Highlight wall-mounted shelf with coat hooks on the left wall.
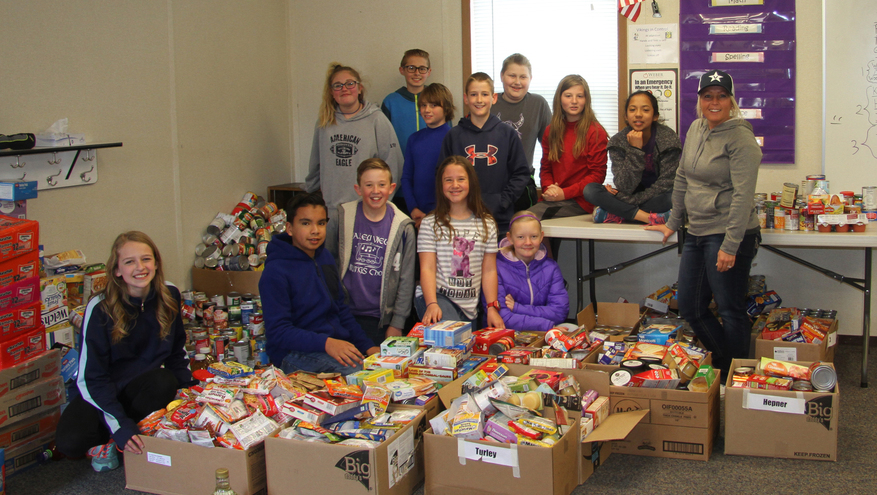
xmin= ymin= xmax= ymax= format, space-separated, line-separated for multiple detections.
xmin=0 ymin=143 xmax=122 ymax=191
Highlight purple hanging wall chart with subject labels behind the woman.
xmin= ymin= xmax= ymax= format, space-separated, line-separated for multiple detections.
xmin=679 ymin=0 xmax=796 ymax=163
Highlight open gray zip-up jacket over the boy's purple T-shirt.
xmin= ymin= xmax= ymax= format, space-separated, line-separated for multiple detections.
xmin=338 ymin=201 xmax=417 ymax=329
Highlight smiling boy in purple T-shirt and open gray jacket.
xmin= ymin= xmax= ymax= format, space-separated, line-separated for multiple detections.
xmin=338 ymin=158 xmax=417 ymax=345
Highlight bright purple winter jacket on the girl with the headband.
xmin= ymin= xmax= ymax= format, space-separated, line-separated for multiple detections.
xmin=485 ymin=239 xmax=569 ymax=332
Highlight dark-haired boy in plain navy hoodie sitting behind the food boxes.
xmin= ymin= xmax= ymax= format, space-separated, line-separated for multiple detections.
xmin=259 ymin=193 xmax=381 ymax=374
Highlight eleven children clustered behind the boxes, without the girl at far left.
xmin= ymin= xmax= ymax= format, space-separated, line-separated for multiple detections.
xmin=270 ymin=50 xmax=681 ymax=372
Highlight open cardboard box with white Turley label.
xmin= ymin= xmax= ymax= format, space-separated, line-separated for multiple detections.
xmin=424 ymin=365 xmax=642 ymax=495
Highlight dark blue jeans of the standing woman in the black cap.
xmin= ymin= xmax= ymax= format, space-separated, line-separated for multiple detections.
xmin=677 ymin=233 xmax=761 ymax=376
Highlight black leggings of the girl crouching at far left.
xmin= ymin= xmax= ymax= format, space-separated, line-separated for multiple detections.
xmin=55 ymin=368 xmax=179 ymax=458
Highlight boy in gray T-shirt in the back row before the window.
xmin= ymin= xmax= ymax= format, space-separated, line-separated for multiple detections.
xmin=492 ymin=53 xmax=551 ymax=210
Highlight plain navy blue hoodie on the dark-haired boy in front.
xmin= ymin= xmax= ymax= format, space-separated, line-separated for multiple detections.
xmin=259 ymin=234 xmax=374 ymax=366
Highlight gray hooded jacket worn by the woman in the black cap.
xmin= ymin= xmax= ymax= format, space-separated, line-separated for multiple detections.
xmin=667 ymin=118 xmax=762 ymax=256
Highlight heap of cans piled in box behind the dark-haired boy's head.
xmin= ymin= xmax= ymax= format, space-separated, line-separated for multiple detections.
xmin=195 ymin=192 xmax=286 ymax=271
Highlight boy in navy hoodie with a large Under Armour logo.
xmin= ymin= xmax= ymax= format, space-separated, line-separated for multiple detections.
xmin=439 ymin=72 xmax=530 ymax=236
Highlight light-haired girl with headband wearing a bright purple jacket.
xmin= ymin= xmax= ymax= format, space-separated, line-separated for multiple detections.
xmin=496 ymin=211 xmax=569 ymax=332
